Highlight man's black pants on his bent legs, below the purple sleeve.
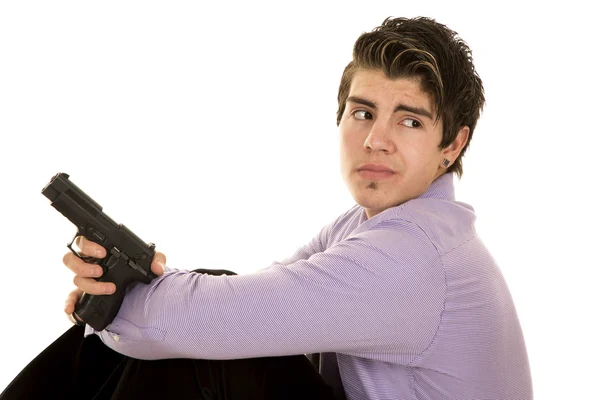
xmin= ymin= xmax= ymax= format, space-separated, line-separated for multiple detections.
xmin=0 ymin=270 xmax=334 ymax=400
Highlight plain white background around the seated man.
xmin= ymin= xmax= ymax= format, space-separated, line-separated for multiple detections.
xmin=0 ymin=1 xmax=600 ymax=400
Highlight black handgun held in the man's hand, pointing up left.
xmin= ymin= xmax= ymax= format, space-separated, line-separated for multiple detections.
xmin=42 ymin=173 xmax=157 ymax=331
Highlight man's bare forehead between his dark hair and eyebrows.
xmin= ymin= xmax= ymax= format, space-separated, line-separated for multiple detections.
xmin=348 ymin=69 xmax=433 ymax=111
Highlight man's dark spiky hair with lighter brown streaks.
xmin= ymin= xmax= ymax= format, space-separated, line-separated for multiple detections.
xmin=337 ymin=17 xmax=485 ymax=177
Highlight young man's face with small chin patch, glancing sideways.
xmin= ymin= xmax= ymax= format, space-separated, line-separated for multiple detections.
xmin=340 ymin=70 xmax=462 ymax=218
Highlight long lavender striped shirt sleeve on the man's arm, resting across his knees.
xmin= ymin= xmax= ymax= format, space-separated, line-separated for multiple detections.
xmin=97 ymin=221 xmax=445 ymax=362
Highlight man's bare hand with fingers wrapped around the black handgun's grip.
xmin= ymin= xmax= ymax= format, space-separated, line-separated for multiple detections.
xmin=63 ymin=236 xmax=167 ymax=317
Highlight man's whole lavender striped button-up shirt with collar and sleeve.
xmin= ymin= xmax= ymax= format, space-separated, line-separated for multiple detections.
xmin=86 ymin=174 xmax=533 ymax=400
